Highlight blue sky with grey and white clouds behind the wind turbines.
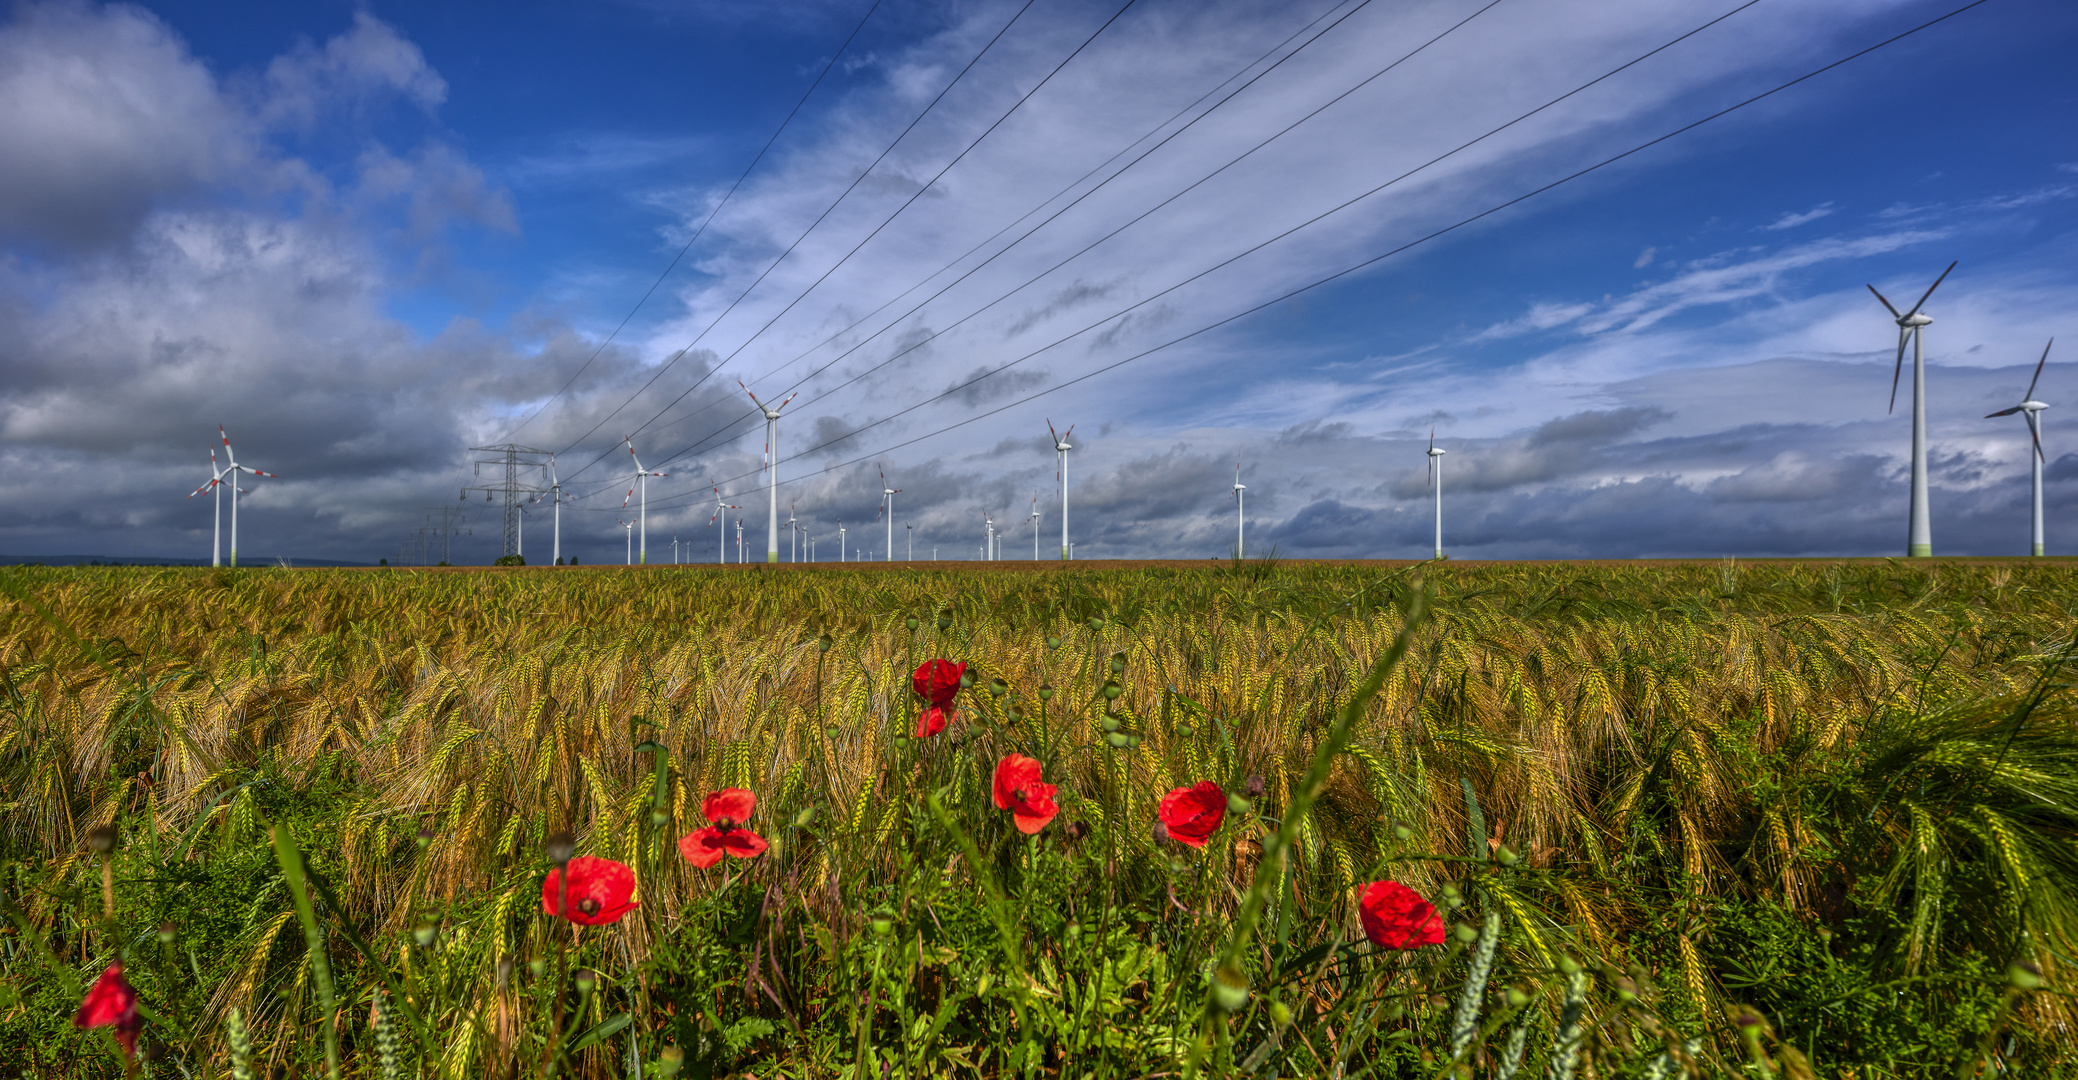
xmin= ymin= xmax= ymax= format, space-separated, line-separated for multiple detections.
xmin=0 ymin=0 xmax=2078 ymax=565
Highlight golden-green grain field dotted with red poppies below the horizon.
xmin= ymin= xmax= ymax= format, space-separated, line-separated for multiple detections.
xmin=0 ymin=561 xmax=2078 ymax=1080
